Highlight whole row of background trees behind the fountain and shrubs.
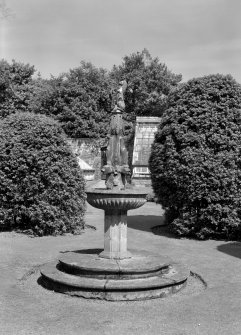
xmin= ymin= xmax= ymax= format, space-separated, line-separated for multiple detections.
xmin=0 ymin=49 xmax=181 ymax=139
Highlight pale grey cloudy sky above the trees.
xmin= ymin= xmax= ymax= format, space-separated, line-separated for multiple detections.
xmin=0 ymin=0 xmax=241 ymax=83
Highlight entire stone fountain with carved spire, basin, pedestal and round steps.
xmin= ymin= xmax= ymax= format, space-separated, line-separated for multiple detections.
xmin=41 ymin=80 xmax=190 ymax=301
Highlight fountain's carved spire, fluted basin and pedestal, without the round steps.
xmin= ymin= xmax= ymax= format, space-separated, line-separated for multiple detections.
xmin=87 ymin=80 xmax=148 ymax=259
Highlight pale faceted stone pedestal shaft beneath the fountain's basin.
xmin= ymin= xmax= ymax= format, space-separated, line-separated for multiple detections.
xmin=99 ymin=209 xmax=131 ymax=259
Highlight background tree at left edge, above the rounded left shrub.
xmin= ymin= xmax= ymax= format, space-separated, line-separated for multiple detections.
xmin=0 ymin=60 xmax=35 ymax=118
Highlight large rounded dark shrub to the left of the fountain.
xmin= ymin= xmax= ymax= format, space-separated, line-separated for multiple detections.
xmin=0 ymin=112 xmax=85 ymax=236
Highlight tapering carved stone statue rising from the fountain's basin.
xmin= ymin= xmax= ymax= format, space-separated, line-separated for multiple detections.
xmin=102 ymin=80 xmax=130 ymax=189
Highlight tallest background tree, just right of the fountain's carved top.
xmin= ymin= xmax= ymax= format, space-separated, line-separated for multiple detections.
xmin=110 ymin=49 xmax=181 ymax=135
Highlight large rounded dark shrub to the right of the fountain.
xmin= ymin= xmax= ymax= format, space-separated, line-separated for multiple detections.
xmin=150 ymin=75 xmax=241 ymax=239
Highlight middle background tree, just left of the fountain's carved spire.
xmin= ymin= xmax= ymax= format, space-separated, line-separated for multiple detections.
xmin=34 ymin=62 xmax=114 ymax=138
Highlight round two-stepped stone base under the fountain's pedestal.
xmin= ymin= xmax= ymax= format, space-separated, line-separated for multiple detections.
xmin=41 ymin=250 xmax=190 ymax=301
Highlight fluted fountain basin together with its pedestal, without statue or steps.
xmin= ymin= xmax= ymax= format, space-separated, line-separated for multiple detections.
xmin=86 ymin=189 xmax=147 ymax=259
